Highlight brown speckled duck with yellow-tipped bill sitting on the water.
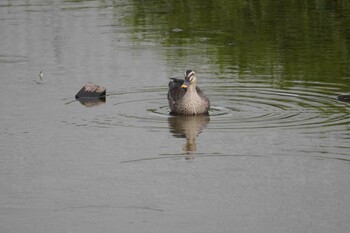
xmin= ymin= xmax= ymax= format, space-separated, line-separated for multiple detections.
xmin=167 ymin=70 xmax=210 ymax=115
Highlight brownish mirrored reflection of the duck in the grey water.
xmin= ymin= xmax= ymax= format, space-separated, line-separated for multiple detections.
xmin=168 ymin=115 xmax=210 ymax=159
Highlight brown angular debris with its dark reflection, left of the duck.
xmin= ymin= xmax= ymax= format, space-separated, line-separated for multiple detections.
xmin=75 ymin=82 xmax=107 ymax=107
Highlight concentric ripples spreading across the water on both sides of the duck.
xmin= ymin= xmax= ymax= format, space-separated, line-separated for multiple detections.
xmin=69 ymin=81 xmax=350 ymax=133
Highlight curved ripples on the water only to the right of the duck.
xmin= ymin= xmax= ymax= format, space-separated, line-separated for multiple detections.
xmin=208 ymin=80 xmax=350 ymax=129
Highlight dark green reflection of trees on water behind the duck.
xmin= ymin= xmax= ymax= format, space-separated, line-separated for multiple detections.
xmin=127 ymin=0 xmax=350 ymax=82
